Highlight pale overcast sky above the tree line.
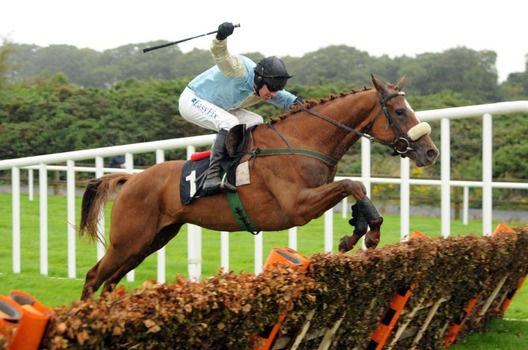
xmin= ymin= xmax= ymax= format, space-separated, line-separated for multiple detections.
xmin=0 ymin=0 xmax=528 ymax=81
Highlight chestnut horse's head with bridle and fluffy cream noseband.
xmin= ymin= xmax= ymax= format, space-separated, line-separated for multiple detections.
xmin=370 ymin=76 xmax=439 ymax=167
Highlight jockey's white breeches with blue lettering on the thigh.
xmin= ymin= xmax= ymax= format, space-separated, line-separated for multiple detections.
xmin=179 ymin=87 xmax=264 ymax=131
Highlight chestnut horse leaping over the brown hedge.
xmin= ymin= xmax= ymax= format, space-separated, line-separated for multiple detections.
xmin=79 ymin=75 xmax=439 ymax=299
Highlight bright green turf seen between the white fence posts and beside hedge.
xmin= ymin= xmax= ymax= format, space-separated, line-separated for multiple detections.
xmin=0 ymin=194 xmax=528 ymax=350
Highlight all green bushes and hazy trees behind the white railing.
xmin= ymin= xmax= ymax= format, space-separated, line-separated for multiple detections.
xmin=0 ymin=42 xmax=528 ymax=208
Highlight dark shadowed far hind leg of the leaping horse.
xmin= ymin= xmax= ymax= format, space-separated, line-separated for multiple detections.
xmin=104 ymin=224 xmax=183 ymax=292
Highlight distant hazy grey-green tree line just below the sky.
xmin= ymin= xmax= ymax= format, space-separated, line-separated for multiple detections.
xmin=8 ymin=41 xmax=528 ymax=102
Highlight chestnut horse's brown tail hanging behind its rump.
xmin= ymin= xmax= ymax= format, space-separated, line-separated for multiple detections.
xmin=79 ymin=173 xmax=132 ymax=240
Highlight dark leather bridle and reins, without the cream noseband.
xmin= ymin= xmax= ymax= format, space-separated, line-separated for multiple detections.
xmin=300 ymin=91 xmax=424 ymax=157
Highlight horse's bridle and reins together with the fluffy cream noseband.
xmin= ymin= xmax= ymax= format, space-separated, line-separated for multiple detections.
xmin=301 ymin=91 xmax=431 ymax=157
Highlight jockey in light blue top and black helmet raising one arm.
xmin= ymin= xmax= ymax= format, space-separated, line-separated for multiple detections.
xmin=179 ymin=22 xmax=303 ymax=194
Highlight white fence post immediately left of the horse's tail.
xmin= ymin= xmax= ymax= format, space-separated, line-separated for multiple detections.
xmin=66 ymin=160 xmax=76 ymax=278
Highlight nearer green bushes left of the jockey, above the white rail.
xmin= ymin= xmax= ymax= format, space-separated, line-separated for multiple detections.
xmin=0 ymin=74 xmax=204 ymax=163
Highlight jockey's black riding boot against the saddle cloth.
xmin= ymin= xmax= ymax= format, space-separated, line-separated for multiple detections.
xmin=203 ymin=130 xmax=236 ymax=194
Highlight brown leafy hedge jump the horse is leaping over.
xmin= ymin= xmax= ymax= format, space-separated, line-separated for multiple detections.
xmin=24 ymin=226 xmax=528 ymax=349
